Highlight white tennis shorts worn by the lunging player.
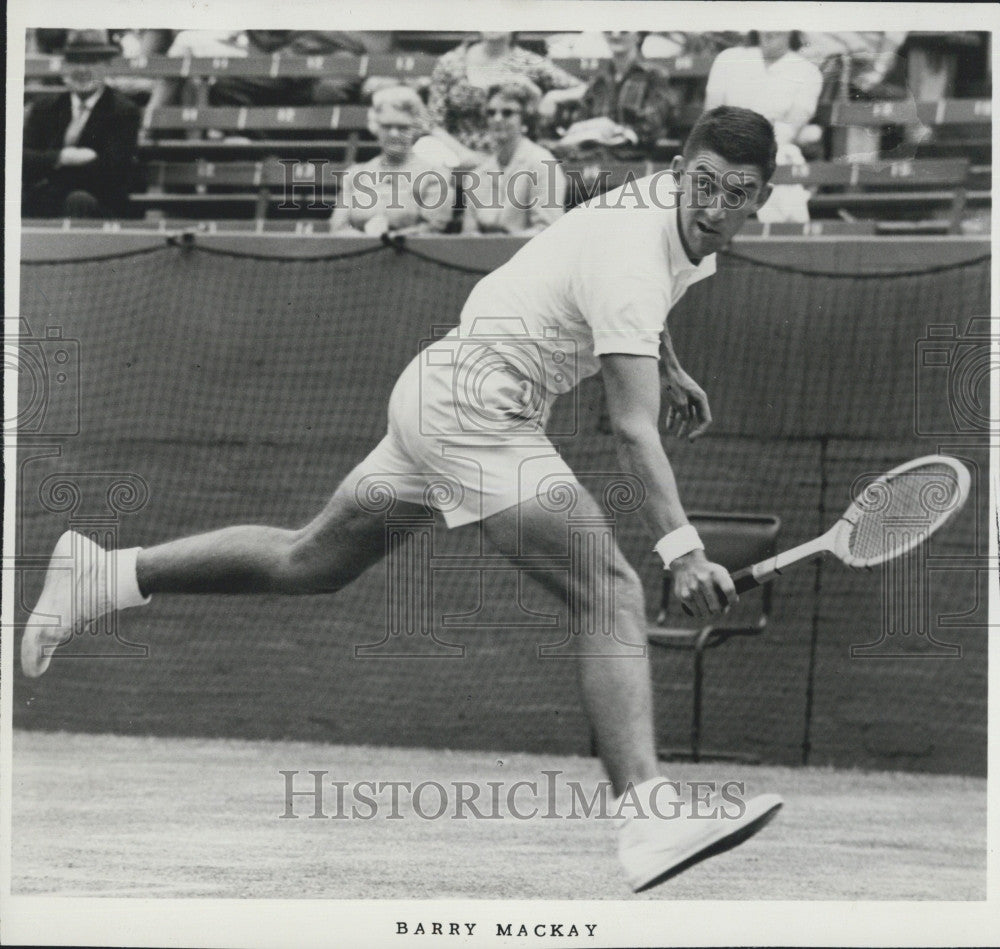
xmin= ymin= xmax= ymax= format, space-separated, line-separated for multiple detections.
xmin=347 ymin=335 xmax=582 ymax=528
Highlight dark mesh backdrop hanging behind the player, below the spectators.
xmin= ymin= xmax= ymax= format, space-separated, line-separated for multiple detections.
xmin=15 ymin=235 xmax=989 ymax=773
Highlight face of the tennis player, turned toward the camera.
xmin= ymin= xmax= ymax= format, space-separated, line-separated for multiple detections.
xmin=671 ymin=149 xmax=771 ymax=257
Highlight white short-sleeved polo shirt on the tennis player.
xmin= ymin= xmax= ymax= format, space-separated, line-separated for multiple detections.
xmin=458 ymin=172 xmax=715 ymax=395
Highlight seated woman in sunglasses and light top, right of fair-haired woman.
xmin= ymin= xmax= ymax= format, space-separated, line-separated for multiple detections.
xmin=462 ymin=83 xmax=566 ymax=236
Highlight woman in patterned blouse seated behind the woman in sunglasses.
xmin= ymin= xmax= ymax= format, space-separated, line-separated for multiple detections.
xmin=427 ymin=33 xmax=586 ymax=168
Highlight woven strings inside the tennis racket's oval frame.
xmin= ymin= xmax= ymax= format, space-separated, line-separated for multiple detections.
xmin=848 ymin=462 xmax=962 ymax=560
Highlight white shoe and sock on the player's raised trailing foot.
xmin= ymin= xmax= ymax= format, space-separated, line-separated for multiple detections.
xmin=21 ymin=531 xmax=149 ymax=678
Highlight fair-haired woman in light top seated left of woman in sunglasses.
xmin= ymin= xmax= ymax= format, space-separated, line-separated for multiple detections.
xmin=330 ymin=86 xmax=453 ymax=234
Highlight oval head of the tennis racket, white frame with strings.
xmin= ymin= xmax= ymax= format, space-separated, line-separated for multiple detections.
xmin=829 ymin=455 xmax=972 ymax=568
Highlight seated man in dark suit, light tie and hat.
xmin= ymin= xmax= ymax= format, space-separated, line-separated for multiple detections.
xmin=21 ymin=30 xmax=142 ymax=217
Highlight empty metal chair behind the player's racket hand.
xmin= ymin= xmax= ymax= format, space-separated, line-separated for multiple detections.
xmin=649 ymin=513 xmax=781 ymax=762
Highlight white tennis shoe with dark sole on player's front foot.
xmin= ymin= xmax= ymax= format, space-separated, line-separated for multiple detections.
xmin=618 ymin=794 xmax=784 ymax=893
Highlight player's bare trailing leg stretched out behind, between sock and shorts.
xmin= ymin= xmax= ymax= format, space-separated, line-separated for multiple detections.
xmin=136 ymin=477 xmax=423 ymax=595
